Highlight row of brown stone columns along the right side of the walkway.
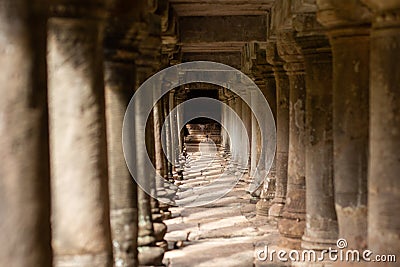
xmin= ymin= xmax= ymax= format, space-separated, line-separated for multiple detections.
xmin=220 ymin=0 xmax=400 ymax=262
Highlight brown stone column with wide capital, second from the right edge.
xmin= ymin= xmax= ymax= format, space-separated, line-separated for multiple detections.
xmin=318 ymin=0 xmax=370 ymax=249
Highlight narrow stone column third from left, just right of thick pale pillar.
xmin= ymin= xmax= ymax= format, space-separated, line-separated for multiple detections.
xmin=104 ymin=15 xmax=138 ymax=267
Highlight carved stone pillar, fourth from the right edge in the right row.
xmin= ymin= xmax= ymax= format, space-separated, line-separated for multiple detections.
xmin=278 ymin=30 xmax=306 ymax=249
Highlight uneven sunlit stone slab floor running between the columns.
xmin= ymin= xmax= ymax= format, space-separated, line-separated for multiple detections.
xmin=164 ymin=143 xmax=285 ymax=267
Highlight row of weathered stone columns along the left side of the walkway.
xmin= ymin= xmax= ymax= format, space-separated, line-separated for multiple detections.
xmin=0 ymin=0 xmax=179 ymax=266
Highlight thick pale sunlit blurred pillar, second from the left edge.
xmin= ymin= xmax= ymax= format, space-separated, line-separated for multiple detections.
xmin=48 ymin=0 xmax=112 ymax=266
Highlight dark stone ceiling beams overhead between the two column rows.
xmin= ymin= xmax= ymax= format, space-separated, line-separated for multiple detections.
xmin=169 ymin=0 xmax=274 ymax=68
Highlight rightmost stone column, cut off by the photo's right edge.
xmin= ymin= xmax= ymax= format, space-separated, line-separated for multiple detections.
xmin=364 ymin=0 xmax=400 ymax=260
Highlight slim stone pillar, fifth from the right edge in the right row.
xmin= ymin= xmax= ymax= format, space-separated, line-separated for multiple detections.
xmin=267 ymin=42 xmax=289 ymax=218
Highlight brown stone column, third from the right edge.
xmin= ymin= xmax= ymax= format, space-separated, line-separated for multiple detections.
xmin=294 ymin=13 xmax=338 ymax=249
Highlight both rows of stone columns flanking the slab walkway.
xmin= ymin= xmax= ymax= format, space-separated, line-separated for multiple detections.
xmin=0 ymin=0 xmax=400 ymax=266
